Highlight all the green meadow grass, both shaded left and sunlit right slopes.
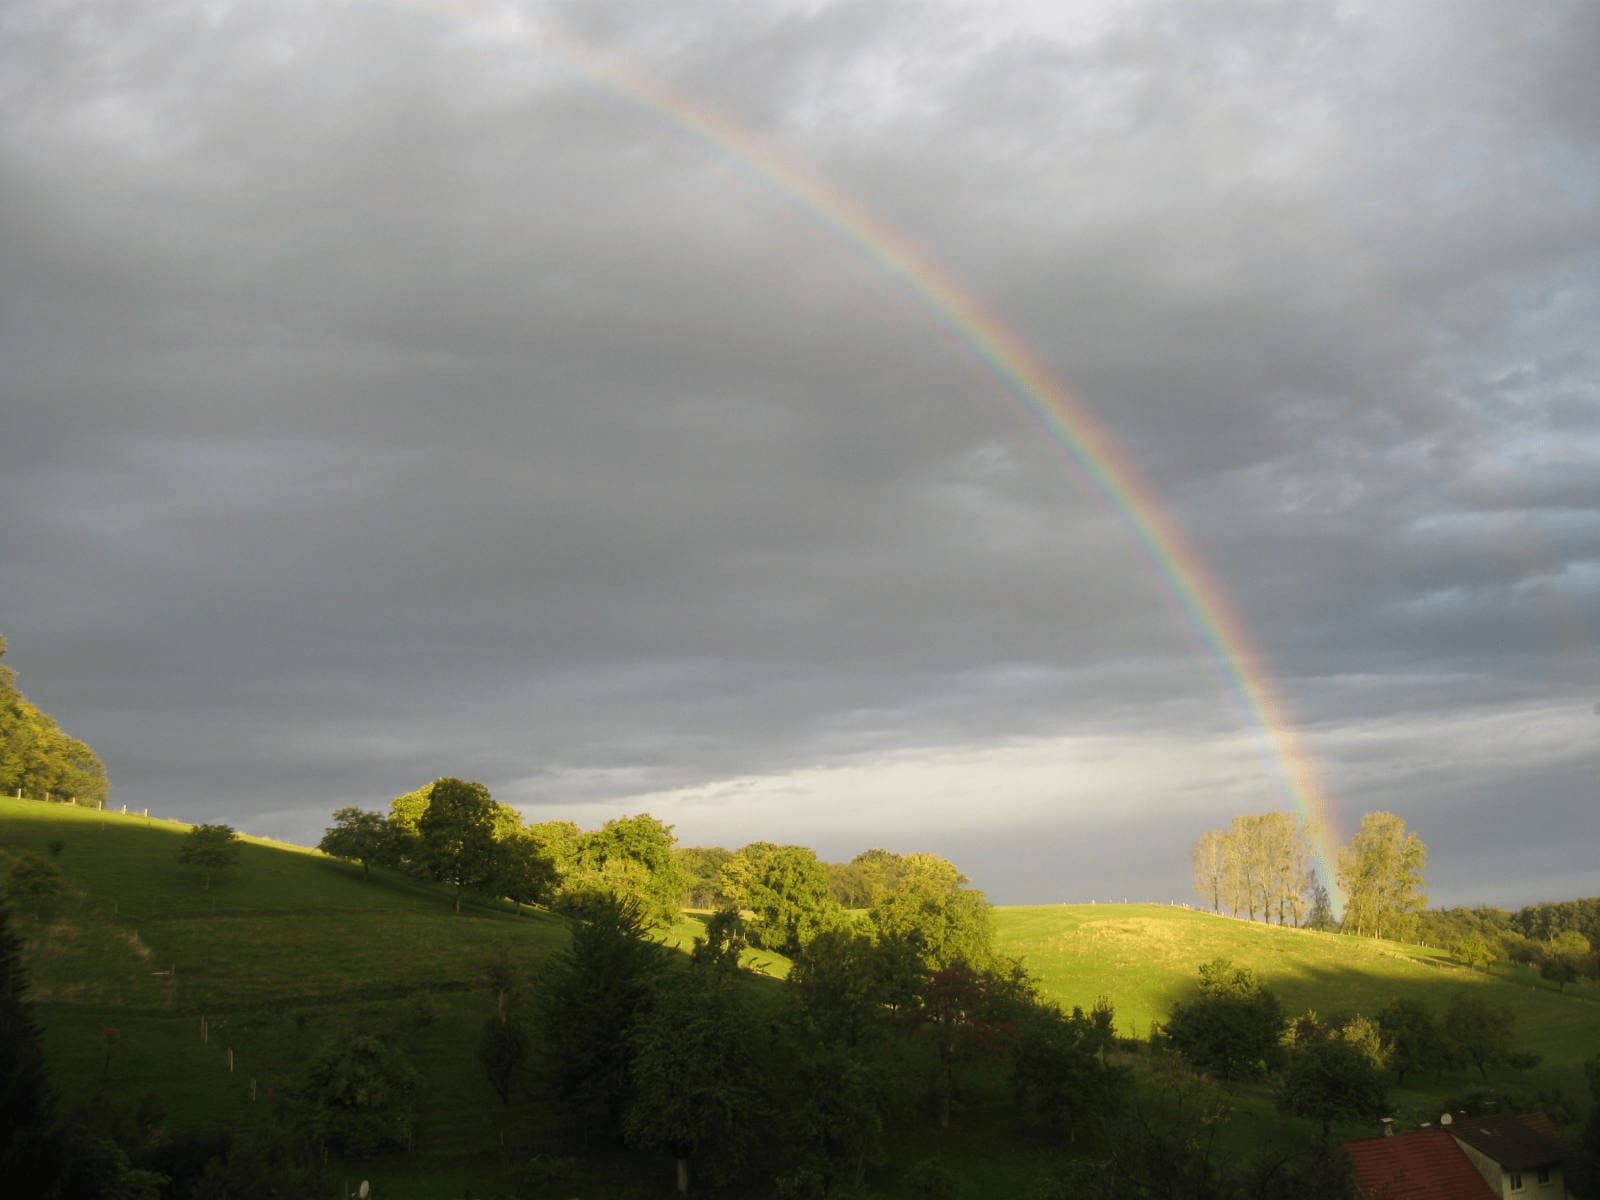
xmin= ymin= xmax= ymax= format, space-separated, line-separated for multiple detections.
xmin=0 ymin=798 xmax=1600 ymax=1200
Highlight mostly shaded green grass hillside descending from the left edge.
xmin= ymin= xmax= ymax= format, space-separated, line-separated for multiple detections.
xmin=0 ymin=798 xmax=789 ymax=1200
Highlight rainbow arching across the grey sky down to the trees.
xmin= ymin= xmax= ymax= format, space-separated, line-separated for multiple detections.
xmin=377 ymin=0 xmax=1344 ymax=915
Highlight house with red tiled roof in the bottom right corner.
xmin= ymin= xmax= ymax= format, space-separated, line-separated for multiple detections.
xmin=1344 ymin=1114 xmax=1570 ymax=1200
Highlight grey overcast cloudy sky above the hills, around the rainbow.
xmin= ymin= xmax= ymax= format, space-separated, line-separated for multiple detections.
xmin=0 ymin=0 xmax=1600 ymax=906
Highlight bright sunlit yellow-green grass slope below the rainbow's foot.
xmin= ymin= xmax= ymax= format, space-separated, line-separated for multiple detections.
xmin=995 ymin=904 xmax=1600 ymax=1096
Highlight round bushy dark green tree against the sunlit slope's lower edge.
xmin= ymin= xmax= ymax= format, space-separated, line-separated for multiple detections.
xmin=1166 ymin=958 xmax=1283 ymax=1082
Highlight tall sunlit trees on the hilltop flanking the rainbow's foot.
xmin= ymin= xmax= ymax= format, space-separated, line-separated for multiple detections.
xmin=1194 ymin=813 xmax=1427 ymax=938
